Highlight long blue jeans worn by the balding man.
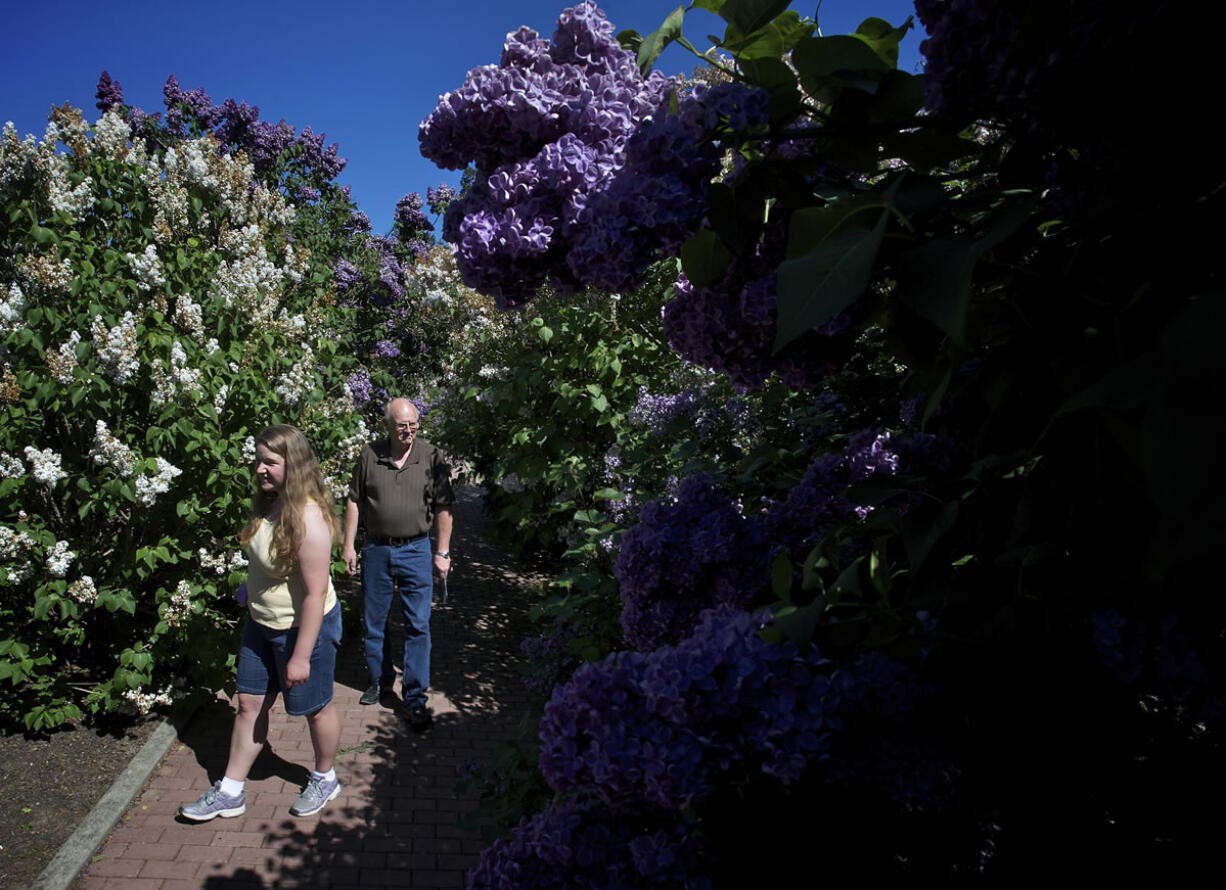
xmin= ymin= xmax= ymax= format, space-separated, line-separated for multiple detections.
xmin=362 ymin=537 xmax=434 ymax=707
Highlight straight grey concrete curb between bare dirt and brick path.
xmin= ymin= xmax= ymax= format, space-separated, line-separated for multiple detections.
xmin=31 ymin=720 xmax=179 ymax=890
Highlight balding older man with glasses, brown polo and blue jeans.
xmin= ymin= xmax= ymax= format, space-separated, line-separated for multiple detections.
xmin=341 ymin=398 xmax=455 ymax=731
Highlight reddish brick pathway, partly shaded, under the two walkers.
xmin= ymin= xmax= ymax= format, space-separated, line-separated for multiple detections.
xmin=75 ymin=489 xmax=541 ymax=890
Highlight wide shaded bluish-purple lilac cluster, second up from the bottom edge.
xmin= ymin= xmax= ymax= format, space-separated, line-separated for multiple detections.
xmin=541 ymin=606 xmax=917 ymax=810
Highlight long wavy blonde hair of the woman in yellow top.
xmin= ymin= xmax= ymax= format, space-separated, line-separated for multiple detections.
xmin=239 ymin=423 xmax=341 ymax=565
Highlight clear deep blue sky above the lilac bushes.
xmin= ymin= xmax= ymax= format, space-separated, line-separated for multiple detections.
xmin=0 ymin=0 xmax=922 ymax=230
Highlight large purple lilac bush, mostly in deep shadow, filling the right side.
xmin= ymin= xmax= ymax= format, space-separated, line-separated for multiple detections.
xmin=421 ymin=0 xmax=1224 ymax=888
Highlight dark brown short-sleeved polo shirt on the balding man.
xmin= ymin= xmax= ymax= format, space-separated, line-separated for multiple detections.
xmin=349 ymin=439 xmax=455 ymax=538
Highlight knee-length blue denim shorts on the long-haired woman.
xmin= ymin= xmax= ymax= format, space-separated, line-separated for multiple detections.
xmin=238 ymin=602 xmax=341 ymax=717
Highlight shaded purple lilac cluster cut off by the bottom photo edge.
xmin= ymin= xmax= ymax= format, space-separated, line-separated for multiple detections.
xmin=468 ymin=801 xmax=711 ymax=890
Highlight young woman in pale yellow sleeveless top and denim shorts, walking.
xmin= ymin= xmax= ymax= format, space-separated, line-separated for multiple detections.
xmin=179 ymin=425 xmax=341 ymax=821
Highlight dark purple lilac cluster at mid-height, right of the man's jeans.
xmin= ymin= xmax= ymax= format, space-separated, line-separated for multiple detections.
xmin=613 ymin=473 xmax=766 ymax=650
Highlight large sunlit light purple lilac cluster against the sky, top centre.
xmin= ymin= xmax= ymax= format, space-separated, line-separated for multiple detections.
xmin=419 ymin=1 xmax=765 ymax=306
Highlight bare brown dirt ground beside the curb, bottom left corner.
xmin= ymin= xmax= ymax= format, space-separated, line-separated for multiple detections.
xmin=0 ymin=717 xmax=159 ymax=890
